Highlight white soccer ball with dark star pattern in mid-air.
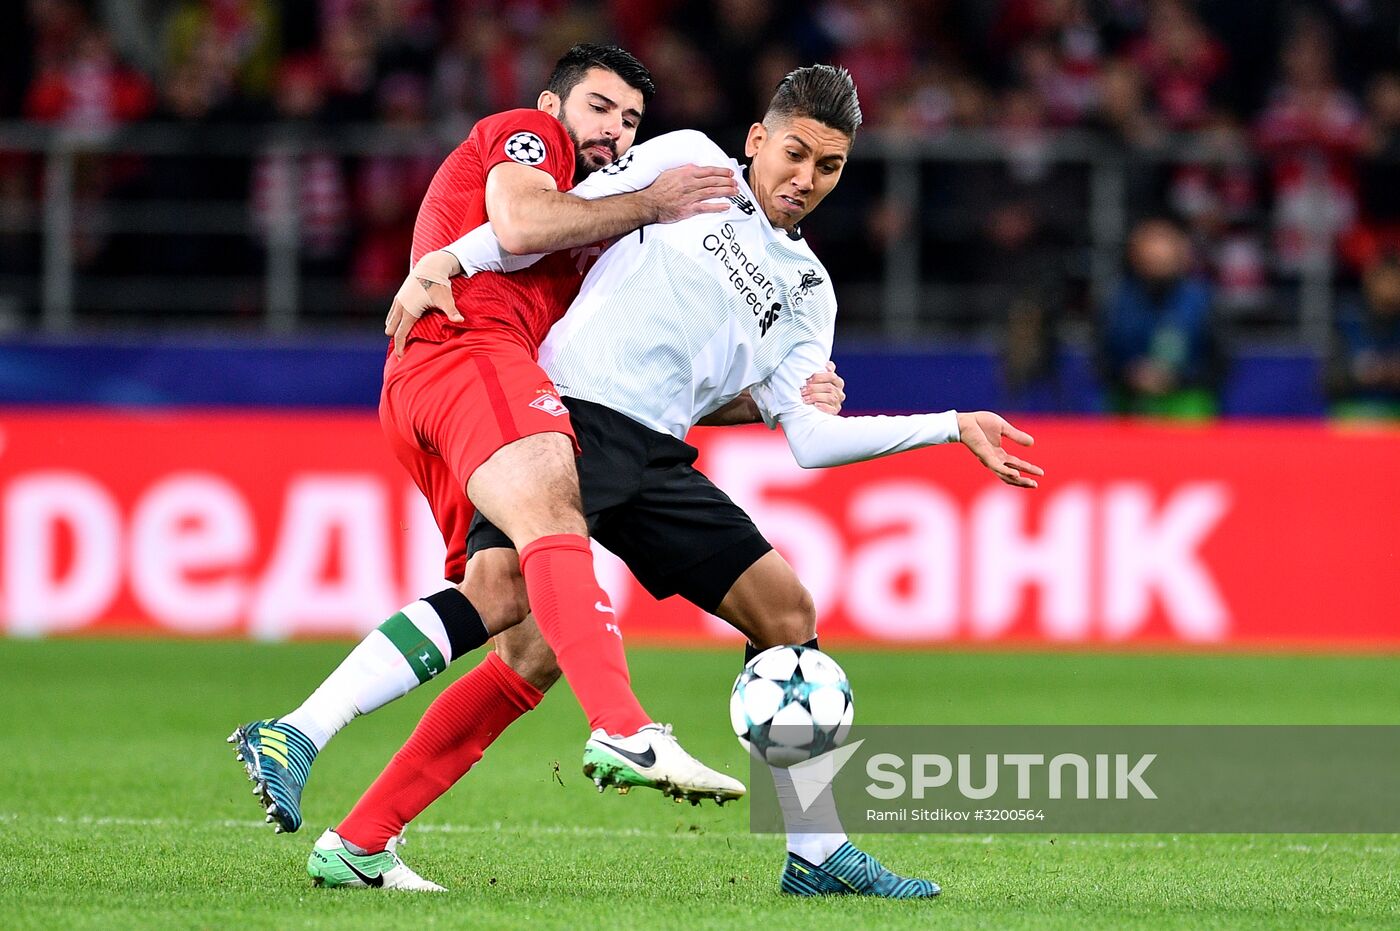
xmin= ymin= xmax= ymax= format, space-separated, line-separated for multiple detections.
xmin=729 ymin=647 xmax=855 ymax=767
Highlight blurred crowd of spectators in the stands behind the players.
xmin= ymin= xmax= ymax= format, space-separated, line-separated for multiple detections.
xmin=0 ymin=0 xmax=1400 ymax=416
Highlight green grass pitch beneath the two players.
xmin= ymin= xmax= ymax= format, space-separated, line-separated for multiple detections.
xmin=0 ymin=640 xmax=1400 ymax=931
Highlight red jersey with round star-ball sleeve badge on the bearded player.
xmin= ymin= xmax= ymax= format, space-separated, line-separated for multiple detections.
xmin=409 ymin=109 xmax=598 ymax=353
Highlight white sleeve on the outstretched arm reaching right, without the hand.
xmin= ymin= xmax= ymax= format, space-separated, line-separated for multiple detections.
xmin=750 ymin=322 xmax=958 ymax=469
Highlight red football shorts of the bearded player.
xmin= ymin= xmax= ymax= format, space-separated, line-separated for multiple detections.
xmin=379 ymin=330 xmax=578 ymax=581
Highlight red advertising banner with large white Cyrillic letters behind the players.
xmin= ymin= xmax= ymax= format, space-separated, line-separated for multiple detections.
xmin=0 ymin=410 xmax=1400 ymax=648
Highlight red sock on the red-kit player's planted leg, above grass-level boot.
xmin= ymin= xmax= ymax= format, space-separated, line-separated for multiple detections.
xmin=336 ymin=652 xmax=545 ymax=853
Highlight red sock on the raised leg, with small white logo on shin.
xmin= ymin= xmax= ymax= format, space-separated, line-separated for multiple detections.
xmin=521 ymin=533 xmax=651 ymax=735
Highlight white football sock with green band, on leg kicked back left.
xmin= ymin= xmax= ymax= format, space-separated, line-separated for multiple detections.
xmin=280 ymin=601 xmax=452 ymax=750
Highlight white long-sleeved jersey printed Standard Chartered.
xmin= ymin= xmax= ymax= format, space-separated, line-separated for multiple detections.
xmin=448 ymin=130 xmax=958 ymax=466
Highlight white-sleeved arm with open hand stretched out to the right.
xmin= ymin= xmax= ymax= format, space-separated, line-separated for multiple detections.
xmin=752 ymin=337 xmax=1044 ymax=489
